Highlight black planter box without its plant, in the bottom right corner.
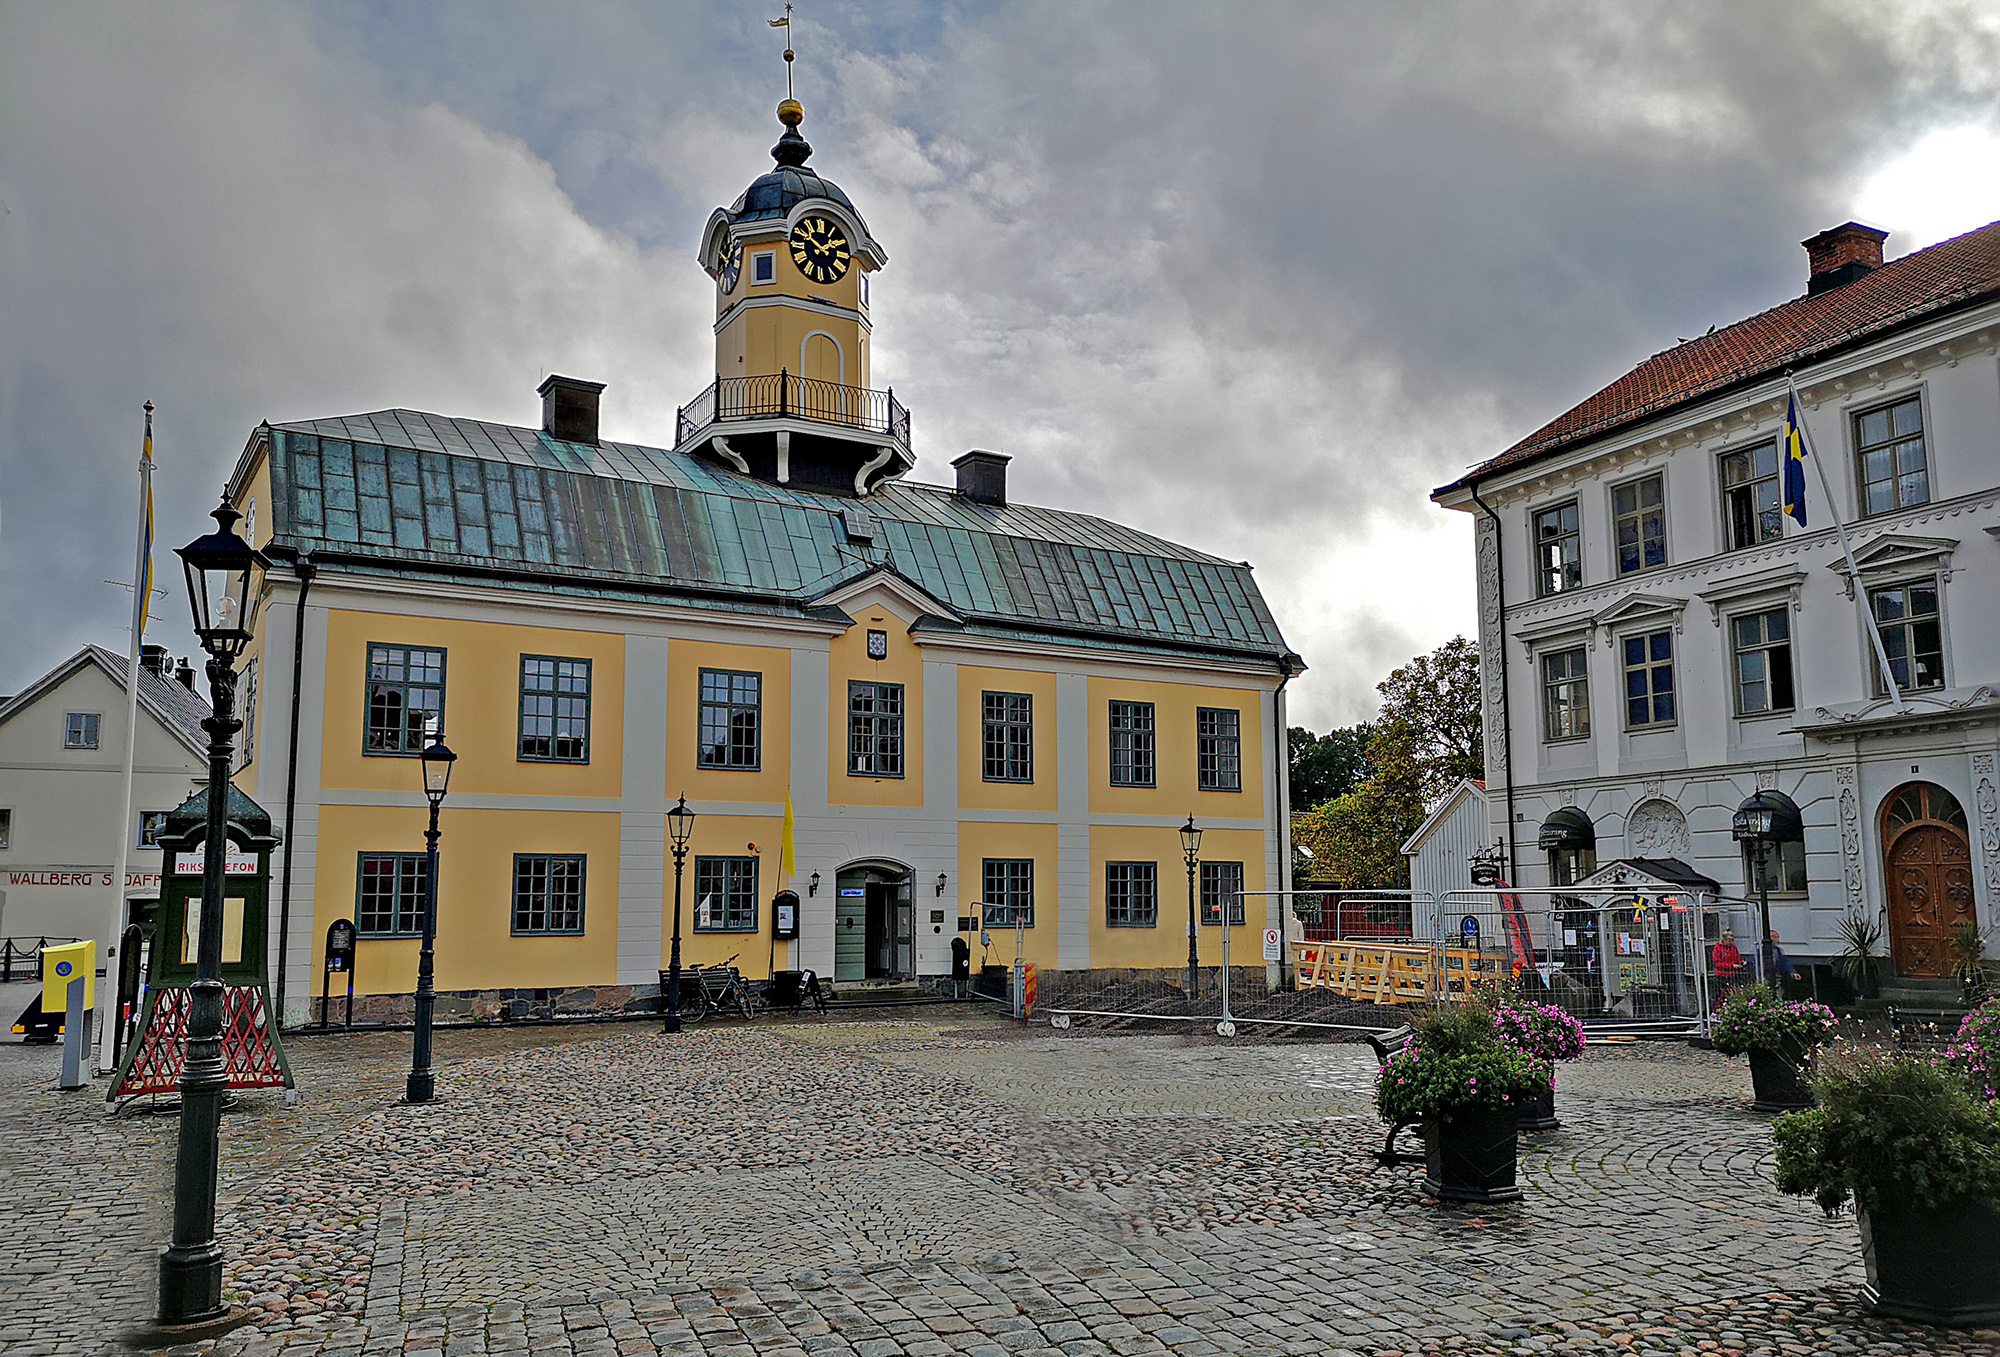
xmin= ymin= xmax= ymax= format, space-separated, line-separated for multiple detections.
xmin=1858 ymin=1201 xmax=2000 ymax=1325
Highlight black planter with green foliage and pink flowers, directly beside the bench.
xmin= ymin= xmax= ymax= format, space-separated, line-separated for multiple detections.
xmin=1376 ymin=1003 xmax=1556 ymax=1203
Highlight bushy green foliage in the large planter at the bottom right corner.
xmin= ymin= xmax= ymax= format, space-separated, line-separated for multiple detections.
xmin=1772 ymin=1043 xmax=2000 ymax=1215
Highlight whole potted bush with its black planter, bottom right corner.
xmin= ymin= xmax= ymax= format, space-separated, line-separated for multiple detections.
xmin=1772 ymin=1013 xmax=2000 ymax=1325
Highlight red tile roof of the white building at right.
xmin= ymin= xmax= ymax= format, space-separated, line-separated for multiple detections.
xmin=1438 ymin=222 xmax=2000 ymax=494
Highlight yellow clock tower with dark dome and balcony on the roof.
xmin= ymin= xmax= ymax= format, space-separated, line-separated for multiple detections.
xmin=676 ymin=98 xmax=914 ymax=494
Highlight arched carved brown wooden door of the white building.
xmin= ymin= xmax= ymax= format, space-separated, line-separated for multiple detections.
xmin=1882 ymin=783 xmax=1976 ymax=977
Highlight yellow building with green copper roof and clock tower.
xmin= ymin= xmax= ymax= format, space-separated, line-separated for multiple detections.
xmin=230 ymin=104 xmax=1302 ymax=1023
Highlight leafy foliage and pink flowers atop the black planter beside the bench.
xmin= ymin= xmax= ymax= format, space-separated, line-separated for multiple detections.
xmin=1376 ymin=1003 xmax=1556 ymax=1121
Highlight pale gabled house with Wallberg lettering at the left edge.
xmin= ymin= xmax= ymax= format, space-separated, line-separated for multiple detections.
xmin=0 ymin=646 xmax=208 ymax=965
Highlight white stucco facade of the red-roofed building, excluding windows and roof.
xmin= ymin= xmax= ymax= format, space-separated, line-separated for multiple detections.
xmin=1438 ymin=236 xmax=2000 ymax=975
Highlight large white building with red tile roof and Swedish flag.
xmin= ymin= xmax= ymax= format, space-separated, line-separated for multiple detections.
xmin=1434 ymin=222 xmax=2000 ymax=979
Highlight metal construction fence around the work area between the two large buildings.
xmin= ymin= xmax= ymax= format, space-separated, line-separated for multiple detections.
xmin=1032 ymin=885 xmax=1766 ymax=1039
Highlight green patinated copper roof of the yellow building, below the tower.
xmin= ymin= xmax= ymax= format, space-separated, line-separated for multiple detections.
xmin=272 ymin=410 xmax=1288 ymax=658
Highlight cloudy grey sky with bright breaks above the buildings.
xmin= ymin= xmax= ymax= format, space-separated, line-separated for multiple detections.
xmin=0 ymin=0 xmax=2000 ymax=731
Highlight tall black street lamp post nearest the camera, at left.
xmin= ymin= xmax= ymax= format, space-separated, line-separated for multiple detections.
xmin=160 ymin=500 xmax=270 ymax=1329
